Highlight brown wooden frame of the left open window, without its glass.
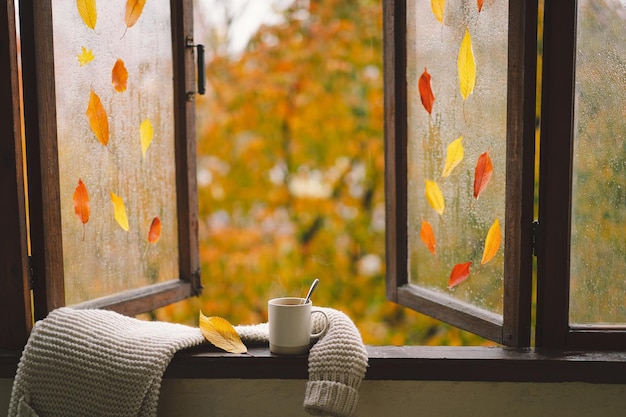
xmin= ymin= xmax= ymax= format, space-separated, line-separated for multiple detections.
xmin=15 ymin=0 xmax=201 ymax=320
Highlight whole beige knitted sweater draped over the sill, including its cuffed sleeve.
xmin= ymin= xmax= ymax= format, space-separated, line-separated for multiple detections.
xmin=8 ymin=308 xmax=367 ymax=417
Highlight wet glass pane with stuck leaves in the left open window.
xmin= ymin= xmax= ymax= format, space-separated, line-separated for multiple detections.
xmin=52 ymin=0 xmax=178 ymax=304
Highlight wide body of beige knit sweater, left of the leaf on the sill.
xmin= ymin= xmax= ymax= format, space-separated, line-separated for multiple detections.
xmin=8 ymin=308 xmax=204 ymax=417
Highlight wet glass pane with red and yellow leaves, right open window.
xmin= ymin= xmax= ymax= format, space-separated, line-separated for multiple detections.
xmin=407 ymin=0 xmax=508 ymax=314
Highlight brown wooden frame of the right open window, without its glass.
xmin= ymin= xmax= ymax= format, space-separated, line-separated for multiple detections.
xmin=383 ymin=0 xmax=537 ymax=346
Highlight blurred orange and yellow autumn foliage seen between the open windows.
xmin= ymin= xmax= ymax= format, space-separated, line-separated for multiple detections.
xmin=156 ymin=0 xmax=485 ymax=345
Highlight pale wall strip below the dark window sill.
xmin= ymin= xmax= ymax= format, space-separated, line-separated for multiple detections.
xmin=0 ymin=378 xmax=626 ymax=417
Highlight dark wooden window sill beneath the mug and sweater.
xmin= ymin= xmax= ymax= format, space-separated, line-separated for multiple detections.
xmin=0 ymin=346 xmax=626 ymax=384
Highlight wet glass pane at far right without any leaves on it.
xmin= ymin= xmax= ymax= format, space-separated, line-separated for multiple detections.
xmin=570 ymin=0 xmax=626 ymax=324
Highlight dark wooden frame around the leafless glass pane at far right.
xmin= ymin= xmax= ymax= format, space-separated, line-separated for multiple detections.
xmin=536 ymin=0 xmax=626 ymax=350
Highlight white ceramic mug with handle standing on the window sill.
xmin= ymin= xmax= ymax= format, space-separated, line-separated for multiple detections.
xmin=267 ymin=297 xmax=328 ymax=355
